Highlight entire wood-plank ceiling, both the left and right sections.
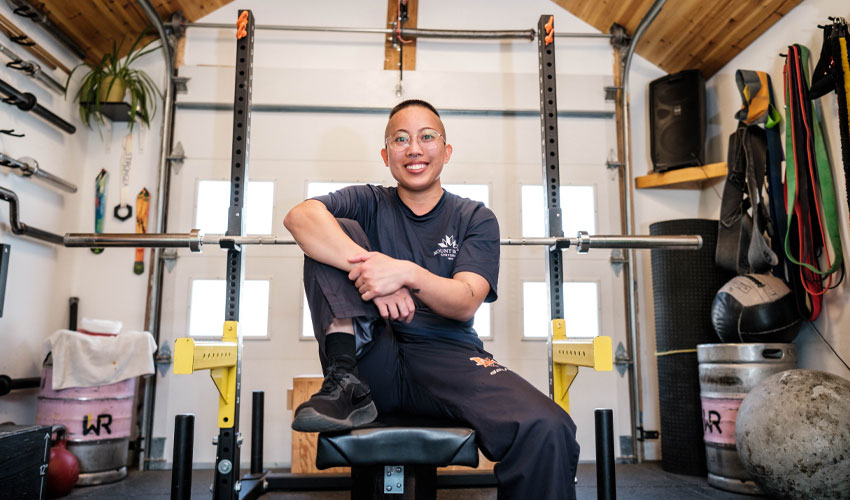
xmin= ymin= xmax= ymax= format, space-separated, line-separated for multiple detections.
xmin=15 ymin=0 xmax=801 ymax=78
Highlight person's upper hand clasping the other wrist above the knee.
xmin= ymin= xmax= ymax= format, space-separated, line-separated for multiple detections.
xmin=348 ymin=252 xmax=410 ymax=301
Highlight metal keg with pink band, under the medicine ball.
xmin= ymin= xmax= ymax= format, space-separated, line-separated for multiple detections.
xmin=697 ymin=343 xmax=797 ymax=495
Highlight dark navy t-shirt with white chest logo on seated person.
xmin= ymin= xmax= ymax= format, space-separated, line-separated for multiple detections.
xmin=315 ymin=184 xmax=499 ymax=347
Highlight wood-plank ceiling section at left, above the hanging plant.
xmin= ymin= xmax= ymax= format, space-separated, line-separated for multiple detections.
xmin=24 ymin=0 xmax=233 ymax=63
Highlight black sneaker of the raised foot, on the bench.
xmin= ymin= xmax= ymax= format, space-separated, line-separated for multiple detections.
xmin=292 ymin=366 xmax=378 ymax=432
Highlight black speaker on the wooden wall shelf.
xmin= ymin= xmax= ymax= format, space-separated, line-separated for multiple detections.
xmin=649 ymin=69 xmax=705 ymax=172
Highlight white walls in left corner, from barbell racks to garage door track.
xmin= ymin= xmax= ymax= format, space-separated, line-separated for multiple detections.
xmin=0 ymin=3 xmax=164 ymax=424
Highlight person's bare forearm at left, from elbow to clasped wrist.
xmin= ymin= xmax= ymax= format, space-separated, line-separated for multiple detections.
xmin=283 ymin=200 xmax=365 ymax=271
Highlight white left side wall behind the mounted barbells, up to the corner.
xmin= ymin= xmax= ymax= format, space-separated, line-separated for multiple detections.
xmin=0 ymin=0 xmax=81 ymax=423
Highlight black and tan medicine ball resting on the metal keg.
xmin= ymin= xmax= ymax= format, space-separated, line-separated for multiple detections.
xmin=711 ymin=274 xmax=800 ymax=343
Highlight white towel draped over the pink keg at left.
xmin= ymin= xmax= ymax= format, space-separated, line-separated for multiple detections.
xmin=47 ymin=330 xmax=156 ymax=389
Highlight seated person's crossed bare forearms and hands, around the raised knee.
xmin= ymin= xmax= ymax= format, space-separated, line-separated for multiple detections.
xmin=283 ymin=200 xmax=490 ymax=322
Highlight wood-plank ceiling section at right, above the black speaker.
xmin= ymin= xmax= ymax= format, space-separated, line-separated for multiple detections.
xmin=552 ymin=0 xmax=801 ymax=78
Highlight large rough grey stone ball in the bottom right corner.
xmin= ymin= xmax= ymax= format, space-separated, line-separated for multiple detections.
xmin=735 ymin=370 xmax=850 ymax=500
